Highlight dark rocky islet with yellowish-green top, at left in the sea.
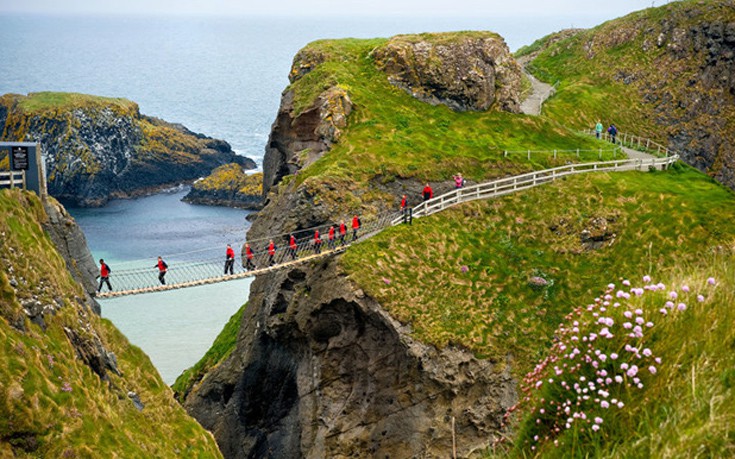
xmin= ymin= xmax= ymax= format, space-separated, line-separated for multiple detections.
xmin=0 ymin=93 xmax=255 ymax=206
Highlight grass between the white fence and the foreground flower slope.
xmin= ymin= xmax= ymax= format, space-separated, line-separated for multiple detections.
xmin=342 ymin=166 xmax=735 ymax=376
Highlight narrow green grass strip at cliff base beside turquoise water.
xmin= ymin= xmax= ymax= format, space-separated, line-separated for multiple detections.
xmin=171 ymin=304 xmax=247 ymax=400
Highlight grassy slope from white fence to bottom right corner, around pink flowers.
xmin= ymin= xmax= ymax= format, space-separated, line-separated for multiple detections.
xmin=342 ymin=166 xmax=735 ymax=457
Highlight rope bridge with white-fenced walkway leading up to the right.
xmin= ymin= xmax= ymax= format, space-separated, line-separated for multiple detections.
xmin=97 ymin=138 xmax=679 ymax=298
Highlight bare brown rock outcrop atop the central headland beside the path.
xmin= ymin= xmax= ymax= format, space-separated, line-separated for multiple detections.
xmin=373 ymin=32 xmax=521 ymax=113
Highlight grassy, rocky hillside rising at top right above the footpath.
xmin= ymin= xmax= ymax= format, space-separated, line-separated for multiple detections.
xmin=528 ymin=0 xmax=735 ymax=188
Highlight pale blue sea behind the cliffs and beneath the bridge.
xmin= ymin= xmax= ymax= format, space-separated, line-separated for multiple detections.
xmin=0 ymin=14 xmax=628 ymax=384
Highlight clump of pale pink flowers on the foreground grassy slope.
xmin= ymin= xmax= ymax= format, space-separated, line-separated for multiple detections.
xmin=506 ymin=276 xmax=715 ymax=451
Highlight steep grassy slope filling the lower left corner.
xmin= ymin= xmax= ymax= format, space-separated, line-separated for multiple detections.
xmin=0 ymin=190 xmax=220 ymax=458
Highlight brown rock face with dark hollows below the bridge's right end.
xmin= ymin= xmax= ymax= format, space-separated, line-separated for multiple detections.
xmin=184 ymin=259 xmax=516 ymax=458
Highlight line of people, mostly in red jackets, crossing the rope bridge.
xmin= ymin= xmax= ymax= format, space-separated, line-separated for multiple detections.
xmin=97 ymin=173 xmax=466 ymax=292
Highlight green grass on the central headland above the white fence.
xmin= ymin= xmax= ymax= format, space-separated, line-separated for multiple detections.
xmin=289 ymin=33 xmax=624 ymax=190
